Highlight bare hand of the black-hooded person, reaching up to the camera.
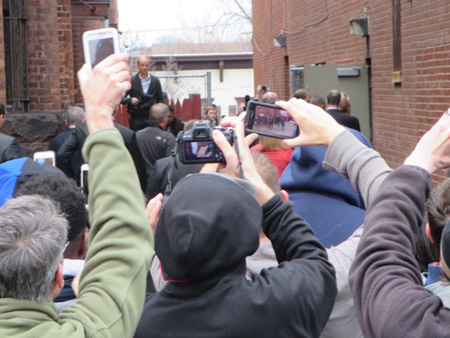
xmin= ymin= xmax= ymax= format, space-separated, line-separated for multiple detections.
xmin=213 ymin=117 xmax=274 ymax=205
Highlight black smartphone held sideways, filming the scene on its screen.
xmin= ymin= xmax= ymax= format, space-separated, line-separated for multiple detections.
xmin=245 ymin=101 xmax=298 ymax=138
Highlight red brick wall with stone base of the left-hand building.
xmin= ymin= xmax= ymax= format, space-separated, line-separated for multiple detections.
xmin=0 ymin=0 xmax=117 ymax=156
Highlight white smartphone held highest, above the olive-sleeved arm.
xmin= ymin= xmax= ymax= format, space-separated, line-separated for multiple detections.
xmin=83 ymin=28 xmax=119 ymax=70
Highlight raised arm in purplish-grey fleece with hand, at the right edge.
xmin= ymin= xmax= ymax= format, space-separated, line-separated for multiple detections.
xmin=350 ymin=114 xmax=450 ymax=337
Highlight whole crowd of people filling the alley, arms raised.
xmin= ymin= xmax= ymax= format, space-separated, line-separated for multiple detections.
xmin=0 ymin=55 xmax=450 ymax=338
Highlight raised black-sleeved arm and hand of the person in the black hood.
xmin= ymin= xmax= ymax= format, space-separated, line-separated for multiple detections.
xmin=213 ymin=119 xmax=336 ymax=337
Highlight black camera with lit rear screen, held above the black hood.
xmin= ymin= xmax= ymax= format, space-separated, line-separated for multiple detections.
xmin=177 ymin=121 xmax=234 ymax=164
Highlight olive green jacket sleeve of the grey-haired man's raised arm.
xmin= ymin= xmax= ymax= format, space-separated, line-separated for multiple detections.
xmin=58 ymin=129 xmax=153 ymax=337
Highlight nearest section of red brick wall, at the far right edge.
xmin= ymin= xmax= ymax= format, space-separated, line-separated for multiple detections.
xmin=371 ymin=0 xmax=450 ymax=181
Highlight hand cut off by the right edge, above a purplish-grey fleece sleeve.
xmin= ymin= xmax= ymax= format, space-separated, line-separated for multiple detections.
xmin=405 ymin=112 xmax=450 ymax=174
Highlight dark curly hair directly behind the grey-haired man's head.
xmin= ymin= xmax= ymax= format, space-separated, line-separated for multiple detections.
xmin=17 ymin=173 xmax=87 ymax=241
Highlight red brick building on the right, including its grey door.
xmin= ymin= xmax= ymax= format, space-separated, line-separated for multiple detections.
xmin=253 ymin=0 xmax=450 ymax=181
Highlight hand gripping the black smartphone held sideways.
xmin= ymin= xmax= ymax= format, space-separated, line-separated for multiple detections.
xmin=276 ymin=98 xmax=345 ymax=148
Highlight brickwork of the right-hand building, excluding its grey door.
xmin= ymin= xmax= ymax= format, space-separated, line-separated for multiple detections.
xmin=253 ymin=0 xmax=450 ymax=181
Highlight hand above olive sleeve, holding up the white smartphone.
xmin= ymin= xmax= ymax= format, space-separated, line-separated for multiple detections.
xmin=78 ymin=54 xmax=131 ymax=133
